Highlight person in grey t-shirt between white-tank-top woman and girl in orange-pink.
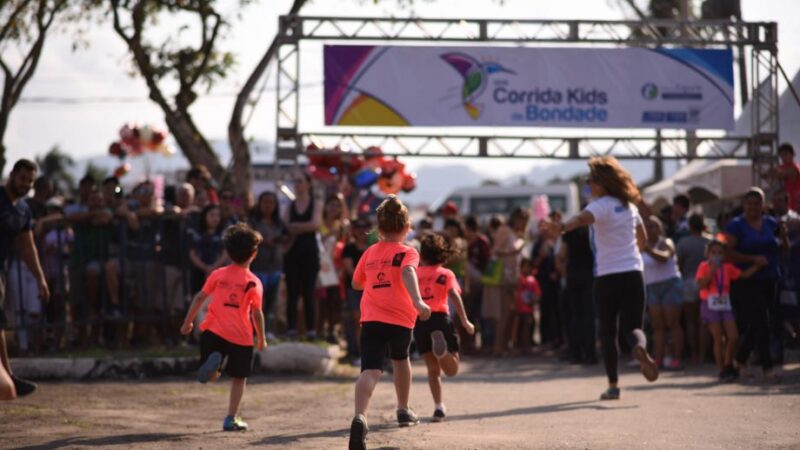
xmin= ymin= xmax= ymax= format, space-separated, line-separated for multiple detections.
xmin=675 ymin=214 xmax=711 ymax=364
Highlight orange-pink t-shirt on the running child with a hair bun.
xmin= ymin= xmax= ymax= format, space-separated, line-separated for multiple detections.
xmin=353 ymin=242 xmax=419 ymax=328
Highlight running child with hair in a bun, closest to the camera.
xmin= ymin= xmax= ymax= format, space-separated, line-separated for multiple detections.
xmin=349 ymin=195 xmax=431 ymax=449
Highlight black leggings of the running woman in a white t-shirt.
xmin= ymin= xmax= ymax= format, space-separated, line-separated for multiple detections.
xmin=594 ymin=271 xmax=647 ymax=383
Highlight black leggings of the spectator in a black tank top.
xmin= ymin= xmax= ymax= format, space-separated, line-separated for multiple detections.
xmin=283 ymin=252 xmax=319 ymax=332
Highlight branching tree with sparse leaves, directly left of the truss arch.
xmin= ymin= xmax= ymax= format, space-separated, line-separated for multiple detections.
xmin=110 ymin=0 xmax=249 ymax=182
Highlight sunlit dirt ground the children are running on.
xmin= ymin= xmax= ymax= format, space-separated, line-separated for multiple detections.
xmin=0 ymin=357 xmax=800 ymax=449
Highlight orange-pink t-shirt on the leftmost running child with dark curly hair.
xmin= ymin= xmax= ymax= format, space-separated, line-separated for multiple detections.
xmin=200 ymin=264 xmax=263 ymax=347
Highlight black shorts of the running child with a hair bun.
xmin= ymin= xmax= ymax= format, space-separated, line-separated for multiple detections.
xmin=361 ymin=322 xmax=411 ymax=372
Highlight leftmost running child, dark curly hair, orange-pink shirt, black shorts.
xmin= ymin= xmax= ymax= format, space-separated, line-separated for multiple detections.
xmin=181 ymin=223 xmax=267 ymax=431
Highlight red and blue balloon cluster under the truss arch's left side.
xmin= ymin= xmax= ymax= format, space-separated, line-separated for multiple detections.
xmin=306 ymin=144 xmax=417 ymax=195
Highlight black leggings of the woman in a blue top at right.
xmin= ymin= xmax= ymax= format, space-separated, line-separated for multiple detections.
xmin=731 ymin=278 xmax=776 ymax=370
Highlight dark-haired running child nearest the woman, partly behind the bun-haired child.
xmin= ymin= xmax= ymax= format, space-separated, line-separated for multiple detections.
xmin=414 ymin=232 xmax=475 ymax=422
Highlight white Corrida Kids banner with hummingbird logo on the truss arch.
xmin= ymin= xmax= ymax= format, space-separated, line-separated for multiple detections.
xmin=324 ymin=45 xmax=734 ymax=130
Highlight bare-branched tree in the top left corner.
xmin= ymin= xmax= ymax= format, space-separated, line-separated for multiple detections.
xmin=0 ymin=0 xmax=68 ymax=173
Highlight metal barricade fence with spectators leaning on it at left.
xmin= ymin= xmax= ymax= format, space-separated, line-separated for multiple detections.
xmin=5 ymin=214 xmax=192 ymax=347
